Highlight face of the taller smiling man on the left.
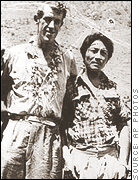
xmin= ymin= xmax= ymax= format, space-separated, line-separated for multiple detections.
xmin=39 ymin=6 xmax=63 ymax=43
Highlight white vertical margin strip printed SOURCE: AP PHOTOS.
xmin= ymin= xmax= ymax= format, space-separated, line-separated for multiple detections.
xmin=131 ymin=0 xmax=139 ymax=180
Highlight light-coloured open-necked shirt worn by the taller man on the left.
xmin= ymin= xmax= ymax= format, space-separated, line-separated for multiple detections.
xmin=3 ymin=39 xmax=77 ymax=118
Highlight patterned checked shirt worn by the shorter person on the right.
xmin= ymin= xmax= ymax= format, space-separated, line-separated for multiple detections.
xmin=63 ymin=69 xmax=131 ymax=147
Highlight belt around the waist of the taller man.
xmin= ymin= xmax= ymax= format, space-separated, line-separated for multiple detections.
xmin=9 ymin=113 xmax=60 ymax=127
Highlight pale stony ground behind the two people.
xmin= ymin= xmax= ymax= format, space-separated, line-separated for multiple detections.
xmin=1 ymin=1 xmax=131 ymax=178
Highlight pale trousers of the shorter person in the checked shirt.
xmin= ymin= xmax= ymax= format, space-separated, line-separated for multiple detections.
xmin=64 ymin=146 xmax=127 ymax=179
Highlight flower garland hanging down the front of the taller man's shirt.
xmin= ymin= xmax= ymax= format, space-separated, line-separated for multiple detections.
xmin=24 ymin=45 xmax=62 ymax=117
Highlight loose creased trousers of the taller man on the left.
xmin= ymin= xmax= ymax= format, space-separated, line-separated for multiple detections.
xmin=1 ymin=120 xmax=62 ymax=179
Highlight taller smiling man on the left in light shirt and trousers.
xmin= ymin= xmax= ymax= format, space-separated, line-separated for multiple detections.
xmin=1 ymin=3 xmax=77 ymax=179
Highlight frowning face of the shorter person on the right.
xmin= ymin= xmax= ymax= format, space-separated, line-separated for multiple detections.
xmin=84 ymin=40 xmax=108 ymax=71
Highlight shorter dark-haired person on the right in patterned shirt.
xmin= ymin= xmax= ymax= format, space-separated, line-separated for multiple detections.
xmin=62 ymin=33 xmax=130 ymax=179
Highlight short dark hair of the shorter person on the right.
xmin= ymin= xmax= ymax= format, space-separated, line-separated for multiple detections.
xmin=80 ymin=32 xmax=114 ymax=60
